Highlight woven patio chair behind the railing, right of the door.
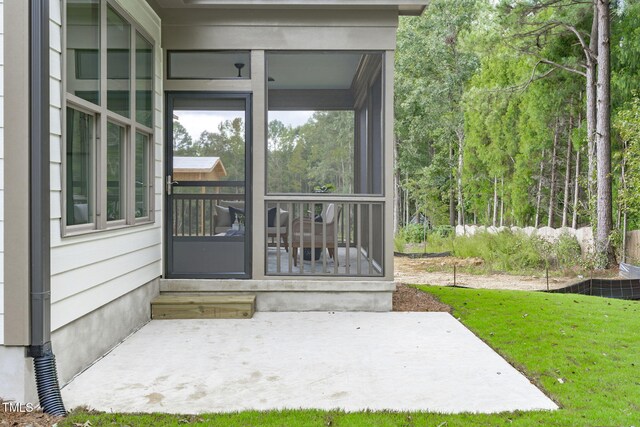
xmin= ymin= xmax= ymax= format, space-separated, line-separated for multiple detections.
xmin=289 ymin=203 xmax=342 ymax=266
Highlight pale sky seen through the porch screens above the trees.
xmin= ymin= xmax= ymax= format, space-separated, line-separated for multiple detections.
xmin=174 ymin=110 xmax=313 ymax=140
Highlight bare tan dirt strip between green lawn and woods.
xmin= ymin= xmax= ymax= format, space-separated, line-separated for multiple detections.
xmin=394 ymin=257 xmax=580 ymax=291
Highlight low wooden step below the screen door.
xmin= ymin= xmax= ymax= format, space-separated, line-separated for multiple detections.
xmin=151 ymin=294 xmax=256 ymax=319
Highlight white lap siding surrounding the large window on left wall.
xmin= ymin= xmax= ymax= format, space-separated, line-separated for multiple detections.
xmin=50 ymin=0 xmax=163 ymax=330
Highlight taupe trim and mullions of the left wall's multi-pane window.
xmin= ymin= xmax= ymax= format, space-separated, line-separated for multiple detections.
xmin=60 ymin=0 xmax=156 ymax=237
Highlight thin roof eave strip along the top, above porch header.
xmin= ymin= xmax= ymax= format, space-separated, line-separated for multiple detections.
xmin=147 ymin=0 xmax=429 ymax=15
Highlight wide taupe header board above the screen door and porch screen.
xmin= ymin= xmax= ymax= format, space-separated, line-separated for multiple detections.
xmin=162 ymin=9 xmax=398 ymax=50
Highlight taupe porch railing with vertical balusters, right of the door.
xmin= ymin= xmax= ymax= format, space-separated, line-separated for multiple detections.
xmin=265 ymin=196 xmax=384 ymax=276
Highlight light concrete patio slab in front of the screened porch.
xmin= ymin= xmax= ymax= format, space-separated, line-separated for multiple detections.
xmin=62 ymin=312 xmax=557 ymax=413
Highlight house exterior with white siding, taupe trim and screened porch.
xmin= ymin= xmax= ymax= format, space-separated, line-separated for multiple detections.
xmin=0 ymin=0 xmax=426 ymax=401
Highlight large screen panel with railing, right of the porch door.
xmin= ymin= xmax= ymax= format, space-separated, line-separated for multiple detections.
xmin=264 ymin=51 xmax=386 ymax=277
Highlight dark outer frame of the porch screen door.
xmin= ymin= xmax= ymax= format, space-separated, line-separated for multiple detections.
xmin=162 ymin=91 xmax=253 ymax=279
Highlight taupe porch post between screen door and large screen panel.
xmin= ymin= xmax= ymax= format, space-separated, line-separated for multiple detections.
xmin=249 ymin=50 xmax=267 ymax=279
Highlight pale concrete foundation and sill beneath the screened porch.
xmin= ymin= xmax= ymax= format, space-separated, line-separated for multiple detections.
xmin=160 ymin=279 xmax=396 ymax=312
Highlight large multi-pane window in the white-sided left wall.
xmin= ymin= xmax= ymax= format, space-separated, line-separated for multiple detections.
xmin=63 ymin=0 xmax=154 ymax=233
